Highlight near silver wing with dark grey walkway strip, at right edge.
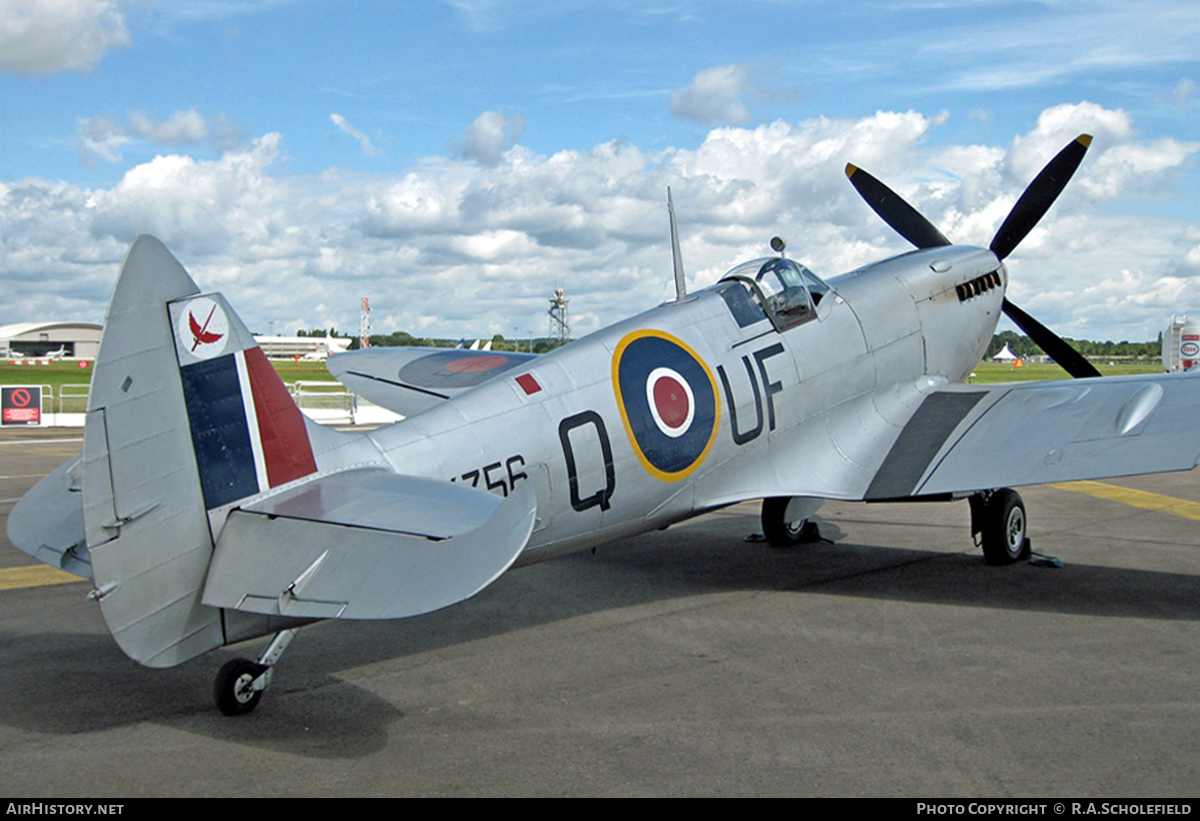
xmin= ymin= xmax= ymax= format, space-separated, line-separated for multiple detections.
xmin=865 ymin=373 xmax=1200 ymax=499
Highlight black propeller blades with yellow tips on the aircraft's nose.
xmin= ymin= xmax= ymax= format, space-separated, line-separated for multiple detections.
xmin=846 ymin=134 xmax=1100 ymax=378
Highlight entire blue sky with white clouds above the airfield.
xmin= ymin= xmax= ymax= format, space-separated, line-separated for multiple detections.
xmin=0 ymin=0 xmax=1200 ymax=341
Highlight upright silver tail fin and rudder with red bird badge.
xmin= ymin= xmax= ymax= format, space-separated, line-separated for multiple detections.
xmin=83 ymin=236 xmax=317 ymax=666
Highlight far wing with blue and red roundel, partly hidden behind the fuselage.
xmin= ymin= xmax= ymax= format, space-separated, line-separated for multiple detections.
xmin=325 ymin=348 xmax=535 ymax=417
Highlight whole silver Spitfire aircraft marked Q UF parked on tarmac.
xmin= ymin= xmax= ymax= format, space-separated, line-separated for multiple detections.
xmin=8 ymin=136 xmax=1200 ymax=714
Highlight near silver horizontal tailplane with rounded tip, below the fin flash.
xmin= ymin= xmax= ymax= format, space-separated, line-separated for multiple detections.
xmin=204 ymin=469 xmax=536 ymax=619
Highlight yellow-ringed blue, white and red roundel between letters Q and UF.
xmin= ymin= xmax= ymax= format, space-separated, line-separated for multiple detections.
xmin=612 ymin=330 xmax=720 ymax=481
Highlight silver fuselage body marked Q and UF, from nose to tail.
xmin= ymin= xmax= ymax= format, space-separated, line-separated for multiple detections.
xmin=371 ymin=246 xmax=1007 ymax=563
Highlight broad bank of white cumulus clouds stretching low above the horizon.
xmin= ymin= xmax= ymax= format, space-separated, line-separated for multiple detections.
xmin=0 ymin=103 xmax=1200 ymax=340
